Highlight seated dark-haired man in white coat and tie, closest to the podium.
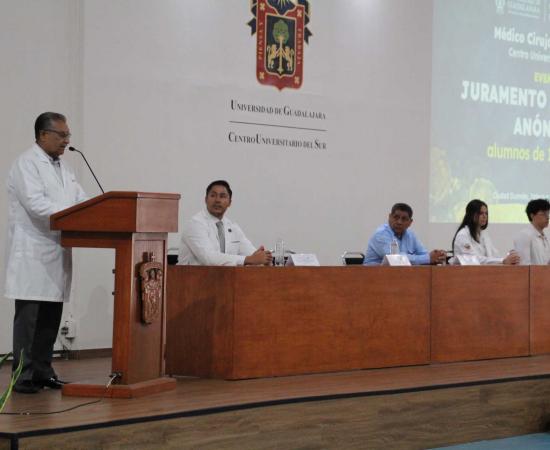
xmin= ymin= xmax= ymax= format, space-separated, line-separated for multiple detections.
xmin=179 ymin=180 xmax=272 ymax=266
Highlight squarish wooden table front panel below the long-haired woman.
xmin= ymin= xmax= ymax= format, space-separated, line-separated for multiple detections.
xmin=431 ymin=266 xmax=529 ymax=362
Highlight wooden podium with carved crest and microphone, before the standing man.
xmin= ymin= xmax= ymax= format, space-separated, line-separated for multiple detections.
xmin=50 ymin=192 xmax=180 ymax=398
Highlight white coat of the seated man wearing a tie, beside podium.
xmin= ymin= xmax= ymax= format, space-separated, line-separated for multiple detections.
xmin=178 ymin=208 xmax=256 ymax=266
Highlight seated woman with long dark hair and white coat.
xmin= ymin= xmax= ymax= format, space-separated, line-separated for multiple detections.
xmin=453 ymin=199 xmax=519 ymax=264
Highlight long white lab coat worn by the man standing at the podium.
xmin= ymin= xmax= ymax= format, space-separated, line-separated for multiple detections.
xmin=4 ymin=144 xmax=86 ymax=302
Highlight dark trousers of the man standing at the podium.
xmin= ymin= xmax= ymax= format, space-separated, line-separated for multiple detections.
xmin=13 ymin=300 xmax=63 ymax=381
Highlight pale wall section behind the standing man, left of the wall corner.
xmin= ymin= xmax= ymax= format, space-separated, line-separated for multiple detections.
xmin=0 ymin=0 xmax=87 ymax=353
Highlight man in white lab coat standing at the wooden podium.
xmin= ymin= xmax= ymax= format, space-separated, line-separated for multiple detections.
xmin=5 ymin=112 xmax=86 ymax=394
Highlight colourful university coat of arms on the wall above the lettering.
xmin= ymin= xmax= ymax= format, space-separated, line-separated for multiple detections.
xmin=248 ymin=0 xmax=311 ymax=90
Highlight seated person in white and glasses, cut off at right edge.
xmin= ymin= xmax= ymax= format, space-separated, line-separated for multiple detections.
xmin=514 ymin=198 xmax=550 ymax=266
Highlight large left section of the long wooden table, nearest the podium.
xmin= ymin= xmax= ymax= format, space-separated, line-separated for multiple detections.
xmin=166 ymin=266 xmax=431 ymax=379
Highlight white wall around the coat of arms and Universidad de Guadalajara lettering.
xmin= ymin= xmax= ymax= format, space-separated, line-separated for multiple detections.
xmin=84 ymin=0 xmax=431 ymax=256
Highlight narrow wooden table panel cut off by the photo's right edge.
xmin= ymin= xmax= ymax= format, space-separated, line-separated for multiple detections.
xmin=530 ymin=266 xmax=550 ymax=355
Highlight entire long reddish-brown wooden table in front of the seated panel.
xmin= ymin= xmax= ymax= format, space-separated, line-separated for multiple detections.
xmin=166 ymin=266 xmax=550 ymax=379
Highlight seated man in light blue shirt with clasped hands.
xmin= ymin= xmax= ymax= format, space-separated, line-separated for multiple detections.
xmin=363 ymin=203 xmax=446 ymax=266
